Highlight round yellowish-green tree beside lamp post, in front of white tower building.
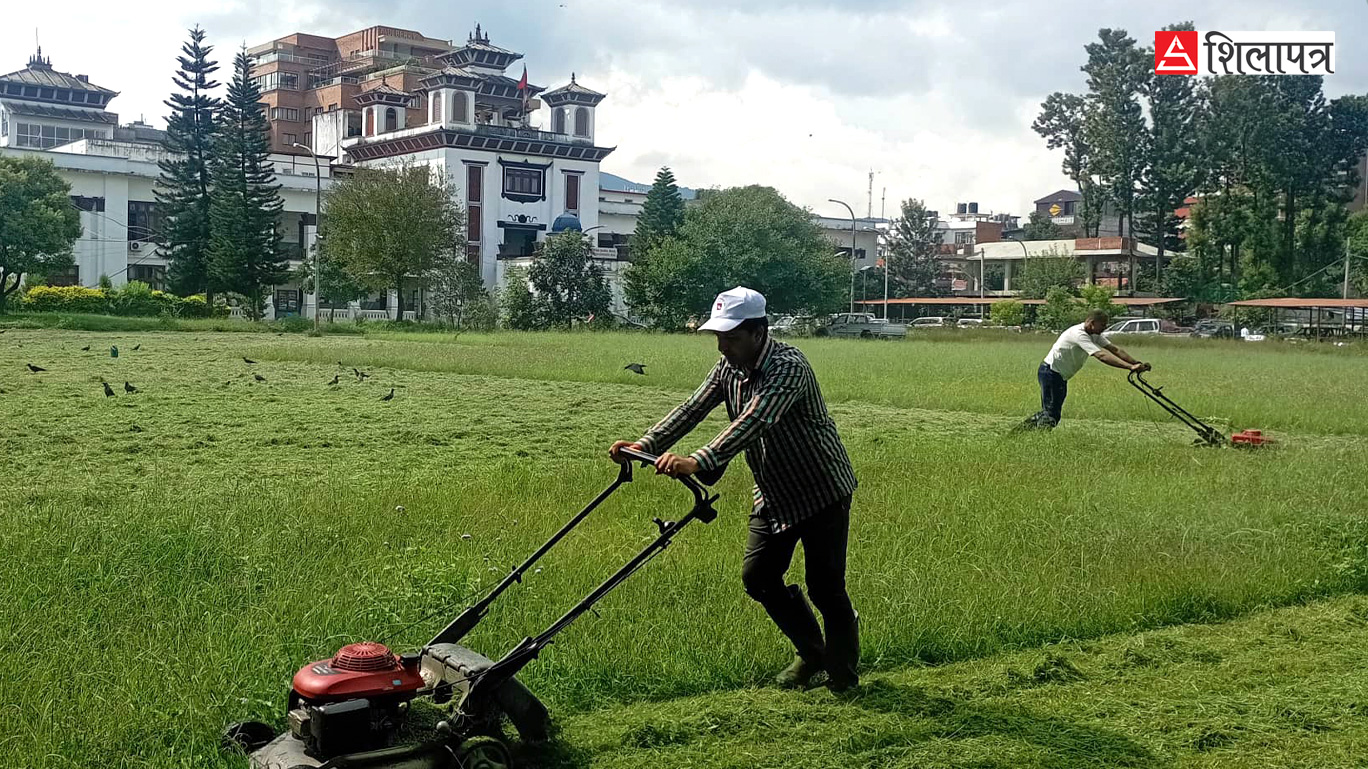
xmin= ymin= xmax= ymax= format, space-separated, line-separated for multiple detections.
xmin=323 ymin=166 xmax=465 ymax=319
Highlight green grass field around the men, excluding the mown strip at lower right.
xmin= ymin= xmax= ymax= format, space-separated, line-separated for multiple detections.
xmin=0 ymin=327 xmax=1368 ymax=768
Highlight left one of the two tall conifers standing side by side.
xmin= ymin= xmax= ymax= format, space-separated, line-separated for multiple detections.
xmin=155 ymin=27 xmax=222 ymax=307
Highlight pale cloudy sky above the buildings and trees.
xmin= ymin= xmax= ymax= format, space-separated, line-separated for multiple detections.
xmin=0 ymin=0 xmax=1368 ymax=216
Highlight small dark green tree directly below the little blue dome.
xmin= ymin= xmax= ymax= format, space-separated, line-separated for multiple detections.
xmin=528 ymin=231 xmax=613 ymax=328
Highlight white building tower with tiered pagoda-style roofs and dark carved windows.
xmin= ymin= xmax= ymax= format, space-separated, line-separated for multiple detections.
xmin=331 ymin=27 xmax=621 ymax=309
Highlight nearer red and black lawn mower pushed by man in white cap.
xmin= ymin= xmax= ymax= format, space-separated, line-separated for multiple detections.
xmin=223 ymin=449 xmax=721 ymax=769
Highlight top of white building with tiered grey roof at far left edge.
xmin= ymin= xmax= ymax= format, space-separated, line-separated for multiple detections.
xmin=0 ymin=48 xmax=119 ymax=149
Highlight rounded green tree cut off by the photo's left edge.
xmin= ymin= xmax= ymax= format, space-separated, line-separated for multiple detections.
xmin=0 ymin=156 xmax=81 ymax=313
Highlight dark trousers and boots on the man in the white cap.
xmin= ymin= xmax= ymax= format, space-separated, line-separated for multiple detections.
xmin=741 ymin=497 xmax=859 ymax=679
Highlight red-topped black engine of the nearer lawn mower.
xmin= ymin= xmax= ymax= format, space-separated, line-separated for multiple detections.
xmin=289 ymin=642 xmax=423 ymax=759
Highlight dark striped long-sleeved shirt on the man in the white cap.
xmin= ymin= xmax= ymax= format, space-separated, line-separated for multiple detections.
xmin=640 ymin=339 xmax=856 ymax=532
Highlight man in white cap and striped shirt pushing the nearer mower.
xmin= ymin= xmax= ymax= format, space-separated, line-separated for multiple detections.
xmin=610 ymin=287 xmax=859 ymax=692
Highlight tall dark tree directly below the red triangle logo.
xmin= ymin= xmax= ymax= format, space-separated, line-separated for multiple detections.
xmin=1138 ymin=22 xmax=1208 ymax=279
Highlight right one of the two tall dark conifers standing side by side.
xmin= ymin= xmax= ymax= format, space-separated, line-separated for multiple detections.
xmin=209 ymin=48 xmax=286 ymax=320
